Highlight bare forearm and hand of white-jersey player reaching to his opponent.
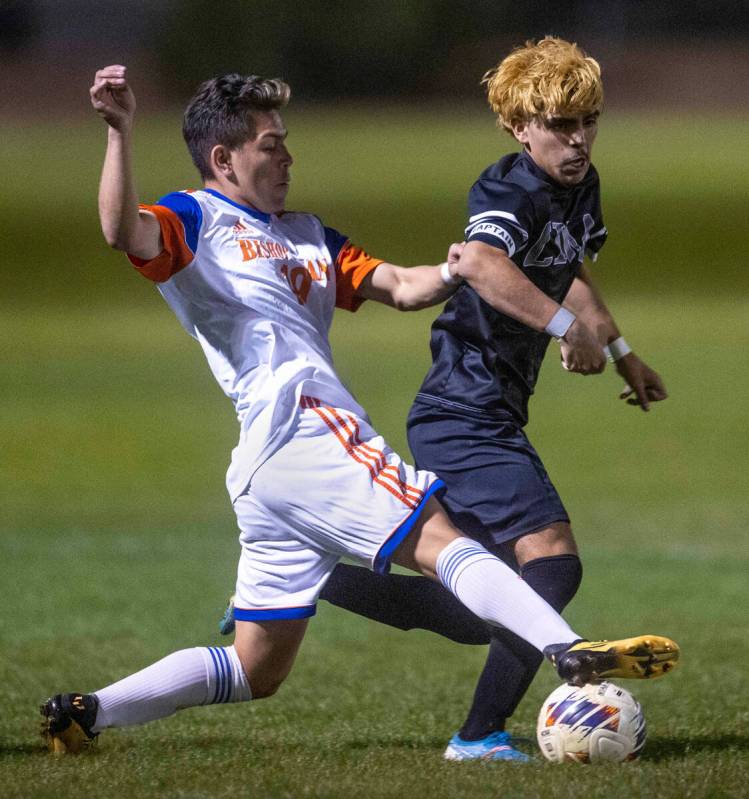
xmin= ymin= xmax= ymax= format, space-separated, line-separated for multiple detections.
xmin=356 ymin=244 xmax=463 ymax=311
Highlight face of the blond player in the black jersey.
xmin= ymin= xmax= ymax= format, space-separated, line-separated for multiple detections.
xmin=513 ymin=111 xmax=598 ymax=186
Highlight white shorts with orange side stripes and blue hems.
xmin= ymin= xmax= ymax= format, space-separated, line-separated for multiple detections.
xmin=234 ymin=397 xmax=444 ymax=621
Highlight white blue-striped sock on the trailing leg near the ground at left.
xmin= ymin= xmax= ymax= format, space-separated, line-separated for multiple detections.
xmin=93 ymin=646 xmax=252 ymax=732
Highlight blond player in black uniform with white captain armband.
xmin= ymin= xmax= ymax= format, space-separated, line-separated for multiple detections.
xmin=219 ymin=37 xmax=666 ymax=761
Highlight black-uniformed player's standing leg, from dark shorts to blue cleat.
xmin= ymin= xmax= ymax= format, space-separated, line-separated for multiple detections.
xmin=400 ymin=398 xmax=581 ymax=760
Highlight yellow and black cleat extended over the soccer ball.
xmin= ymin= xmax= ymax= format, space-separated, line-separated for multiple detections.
xmin=547 ymin=635 xmax=679 ymax=686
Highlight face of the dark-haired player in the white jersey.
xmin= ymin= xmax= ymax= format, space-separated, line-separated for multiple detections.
xmin=231 ymin=111 xmax=294 ymax=214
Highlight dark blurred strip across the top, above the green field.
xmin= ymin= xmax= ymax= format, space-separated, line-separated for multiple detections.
xmin=0 ymin=0 xmax=749 ymax=113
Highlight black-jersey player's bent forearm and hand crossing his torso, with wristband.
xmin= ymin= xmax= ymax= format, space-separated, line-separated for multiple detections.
xmin=457 ymin=241 xmax=606 ymax=374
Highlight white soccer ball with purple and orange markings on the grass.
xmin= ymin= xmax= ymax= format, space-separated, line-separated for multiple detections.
xmin=536 ymin=682 xmax=647 ymax=763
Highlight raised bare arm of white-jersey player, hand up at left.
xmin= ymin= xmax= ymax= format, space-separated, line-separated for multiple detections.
xmin=89 ymin=64 xmax=163 ymax=260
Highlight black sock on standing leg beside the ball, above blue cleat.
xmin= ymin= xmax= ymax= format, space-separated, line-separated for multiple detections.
xmin=452 ymin=555 xmax=582 ymax=741
